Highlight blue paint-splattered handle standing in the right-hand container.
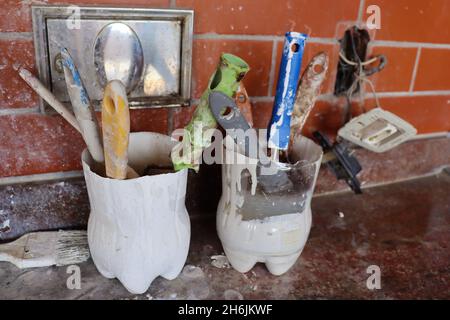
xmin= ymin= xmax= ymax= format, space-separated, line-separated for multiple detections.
xmin=268 ymin=32 xmax=307 ymax=150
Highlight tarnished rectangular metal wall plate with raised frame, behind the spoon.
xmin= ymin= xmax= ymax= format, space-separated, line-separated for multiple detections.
xmin=32 ymin=5 xmax=194 ymax=113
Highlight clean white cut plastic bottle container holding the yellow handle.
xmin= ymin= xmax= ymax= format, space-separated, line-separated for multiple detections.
xmin=82 ymin=132 xmax=191 ymax=294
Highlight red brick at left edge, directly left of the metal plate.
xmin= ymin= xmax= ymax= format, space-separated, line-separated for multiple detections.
xmin=0 ymin=40 xmax=38 ymax=109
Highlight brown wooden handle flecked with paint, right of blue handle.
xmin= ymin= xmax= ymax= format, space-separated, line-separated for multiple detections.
xmin=289 ymin=52 xmax=328 ymax=148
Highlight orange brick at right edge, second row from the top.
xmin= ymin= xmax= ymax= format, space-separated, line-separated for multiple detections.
xmin=414 ymin=48 xmax=450 ymax=91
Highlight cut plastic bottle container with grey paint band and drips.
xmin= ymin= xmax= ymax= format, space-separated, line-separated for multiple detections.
xmin=216 ymin=137 xmax=323 ymax=275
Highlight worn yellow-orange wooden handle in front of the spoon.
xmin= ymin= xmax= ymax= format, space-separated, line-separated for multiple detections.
xmin=102 ymin=80 xmax=130 ymax=179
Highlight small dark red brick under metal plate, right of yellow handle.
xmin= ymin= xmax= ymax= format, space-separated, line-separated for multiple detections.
xmin=130 ymin=108 xmax=168 ymax=134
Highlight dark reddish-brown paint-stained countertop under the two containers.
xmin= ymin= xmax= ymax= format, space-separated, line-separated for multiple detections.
xmin=0 ymin=172 xmax=450 ymax=300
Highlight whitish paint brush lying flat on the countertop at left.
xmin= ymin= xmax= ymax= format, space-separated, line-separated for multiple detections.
xmin=0 ymin=230 xmax=90 ymax=269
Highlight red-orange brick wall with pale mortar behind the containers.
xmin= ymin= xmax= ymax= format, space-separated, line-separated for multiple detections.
xmin=0 ymin=0 xmax=450 ymax=177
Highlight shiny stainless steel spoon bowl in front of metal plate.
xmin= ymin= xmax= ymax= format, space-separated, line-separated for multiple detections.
xmin=94 ymin=22 xmax=144 ymax=93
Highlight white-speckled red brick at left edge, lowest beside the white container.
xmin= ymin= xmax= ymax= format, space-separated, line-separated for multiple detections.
xmin=0 ymin=114 xmax=85 ymax=177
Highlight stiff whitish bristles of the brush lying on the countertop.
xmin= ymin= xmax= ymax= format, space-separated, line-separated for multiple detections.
xmin=55 ymin=231 xmax=90 ymax=266
